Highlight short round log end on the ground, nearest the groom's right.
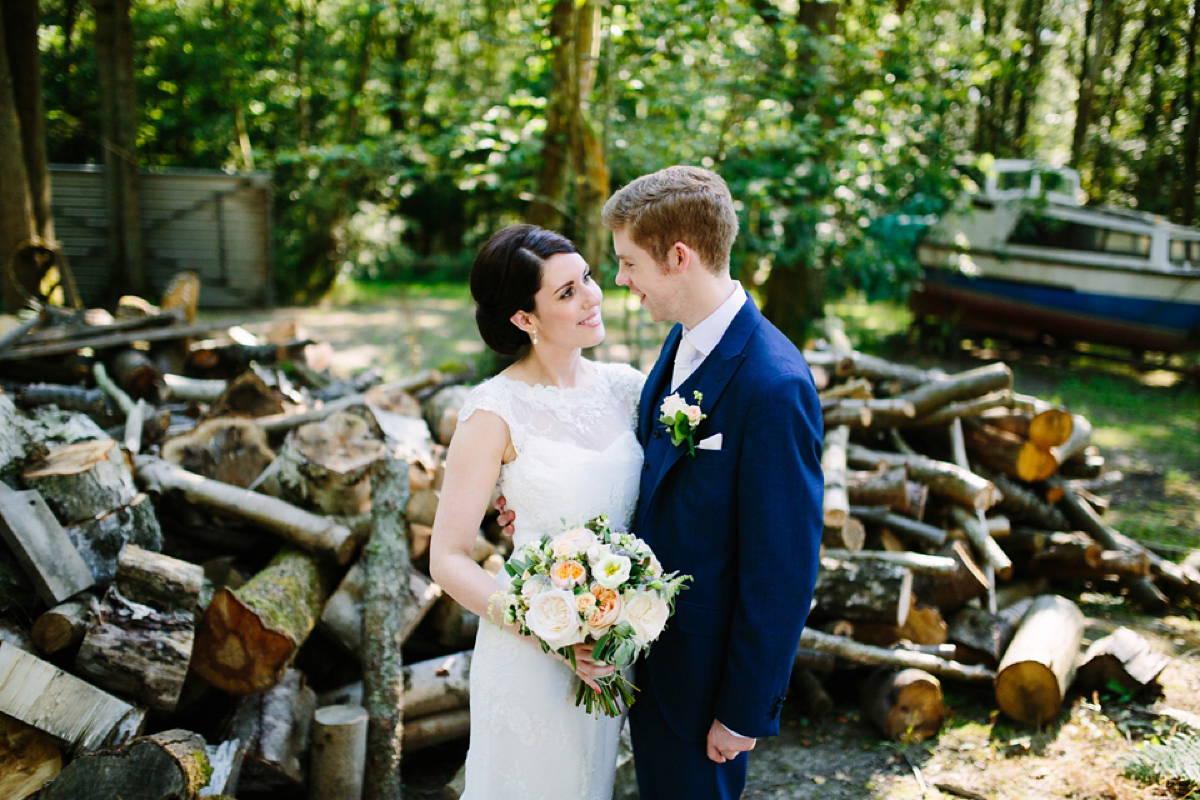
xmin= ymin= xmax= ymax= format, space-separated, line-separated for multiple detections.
xmin=862 ymin=667 xmax=946 ymax=741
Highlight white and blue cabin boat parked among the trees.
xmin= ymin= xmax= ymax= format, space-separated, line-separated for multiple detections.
xmin=910 ymin=158 xmax=1200 ymax=353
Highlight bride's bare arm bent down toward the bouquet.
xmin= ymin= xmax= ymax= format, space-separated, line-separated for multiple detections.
xmin=430 ymin=410 xmax=512 ymax=625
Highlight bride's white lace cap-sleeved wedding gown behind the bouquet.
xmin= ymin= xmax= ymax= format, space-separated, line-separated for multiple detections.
xmin=458 ymin=363 xmax=644 ymax=800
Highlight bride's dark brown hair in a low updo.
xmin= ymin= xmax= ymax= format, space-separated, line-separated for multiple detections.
xmin=470 ymin=224 xmax=578 ymax=355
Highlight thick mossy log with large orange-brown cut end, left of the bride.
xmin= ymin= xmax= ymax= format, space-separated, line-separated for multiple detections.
xmin=192 ymin=547 xmax=329 ymax=694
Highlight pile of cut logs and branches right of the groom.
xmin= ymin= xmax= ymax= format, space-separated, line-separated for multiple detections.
xmin=793 ymin=320 xmax=1180 ymax=739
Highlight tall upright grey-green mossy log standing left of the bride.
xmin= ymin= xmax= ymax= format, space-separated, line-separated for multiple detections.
xmin=362 ymin=459 xmax=412 ymax=800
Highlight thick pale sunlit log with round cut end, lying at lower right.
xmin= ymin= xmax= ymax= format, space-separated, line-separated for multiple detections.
xmin=996 ymin=595 xmax=1084 ymax=727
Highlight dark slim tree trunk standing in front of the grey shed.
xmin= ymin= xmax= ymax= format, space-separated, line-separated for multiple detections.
xmin=92 ymin=0 xmax=150 ymax=300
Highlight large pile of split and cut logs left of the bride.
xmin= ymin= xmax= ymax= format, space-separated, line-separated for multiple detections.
xmin=0 ymin=296 xmax=496 ymax=800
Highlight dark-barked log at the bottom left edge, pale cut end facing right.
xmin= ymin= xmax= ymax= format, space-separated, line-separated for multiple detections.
xmin=40 ymin=729 xmax=211 ymax=800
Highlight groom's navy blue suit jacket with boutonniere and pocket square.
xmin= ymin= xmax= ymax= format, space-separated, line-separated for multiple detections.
xmin=632 ymin=300 xmax=824 ymax=741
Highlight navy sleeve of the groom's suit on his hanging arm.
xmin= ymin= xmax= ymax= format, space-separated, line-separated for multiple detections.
xmin=715 ymin=369 xmax=824 ymax=738
